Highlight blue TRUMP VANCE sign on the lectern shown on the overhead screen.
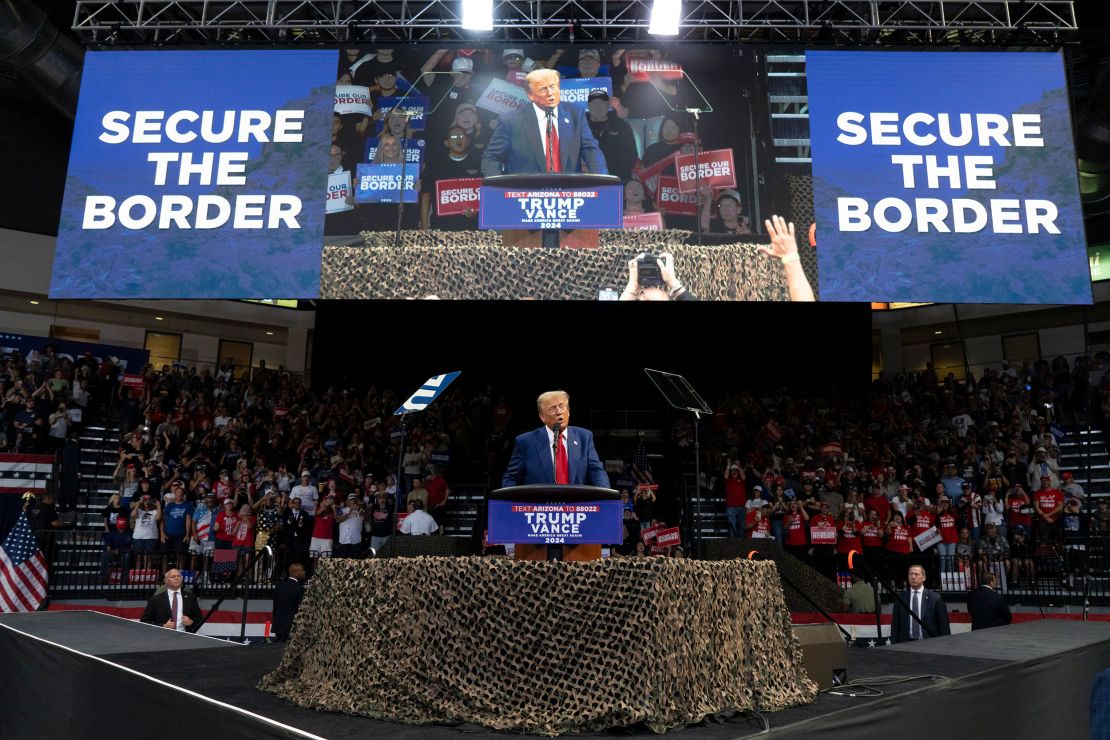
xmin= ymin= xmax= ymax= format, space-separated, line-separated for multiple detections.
xmin=478 ymin=185 xmax=624 ymax=231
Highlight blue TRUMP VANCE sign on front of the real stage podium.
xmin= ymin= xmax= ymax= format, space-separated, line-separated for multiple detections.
xmin=488 ymin=499 xmax=623 ymax=545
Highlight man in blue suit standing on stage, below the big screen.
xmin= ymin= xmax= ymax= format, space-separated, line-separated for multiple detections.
xmin=501 ymin=391 xmax=609 ymax=488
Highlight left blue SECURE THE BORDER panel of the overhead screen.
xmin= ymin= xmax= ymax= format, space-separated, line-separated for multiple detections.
xmin=50 ymin=49 xmax=337 ymax=298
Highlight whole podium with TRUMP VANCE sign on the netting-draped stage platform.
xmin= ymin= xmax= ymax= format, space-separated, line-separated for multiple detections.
xmin=486 ymin=484 xmax=624 ymax=560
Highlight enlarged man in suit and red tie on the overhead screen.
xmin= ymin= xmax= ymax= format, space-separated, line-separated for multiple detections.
xmin=482 ymin=70 xmax=609 ymax=178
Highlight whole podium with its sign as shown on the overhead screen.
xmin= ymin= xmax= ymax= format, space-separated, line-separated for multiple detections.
xmin=478 ymin=172 xmax=624 ymax=247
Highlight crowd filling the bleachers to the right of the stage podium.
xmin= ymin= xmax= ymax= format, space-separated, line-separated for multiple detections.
xmin=709 ymin=357 xmax=1110 ymax=588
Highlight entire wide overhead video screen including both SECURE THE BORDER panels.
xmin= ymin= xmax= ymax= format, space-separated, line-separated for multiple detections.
xmin=50 ymin=43 xmax=1090 ymax=303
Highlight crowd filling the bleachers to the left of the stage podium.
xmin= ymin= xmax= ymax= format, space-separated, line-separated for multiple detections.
xmin=92 ymin=363 xmax=495 ymax=571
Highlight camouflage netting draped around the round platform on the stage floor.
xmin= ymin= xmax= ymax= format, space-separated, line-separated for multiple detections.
xmin=260 ymin=557 xmax=817 ymax=736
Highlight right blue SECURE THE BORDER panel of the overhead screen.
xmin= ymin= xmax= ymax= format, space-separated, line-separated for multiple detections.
xmin=806 ymin=51 xmax=1091 ymax=304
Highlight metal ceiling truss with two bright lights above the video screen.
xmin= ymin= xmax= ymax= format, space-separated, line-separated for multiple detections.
xmin=73 ymin=0 xmax=1077 ymax=47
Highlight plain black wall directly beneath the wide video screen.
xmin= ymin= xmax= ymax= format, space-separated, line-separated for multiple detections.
xmin=313 ymin=301 xmax=870 ymax=408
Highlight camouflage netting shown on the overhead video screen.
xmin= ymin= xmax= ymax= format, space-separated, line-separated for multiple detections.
xmin=321 ymin=230 xmax=788 ymax=301
